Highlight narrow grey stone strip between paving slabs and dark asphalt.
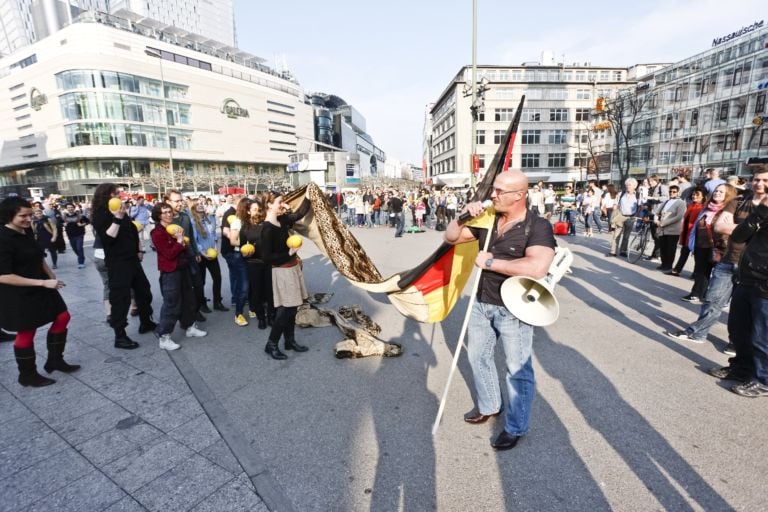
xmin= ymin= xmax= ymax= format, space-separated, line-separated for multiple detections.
xmin=168 ymin=350 xmax=296 ymax=512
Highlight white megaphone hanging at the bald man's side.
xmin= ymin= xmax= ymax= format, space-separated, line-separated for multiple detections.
xmin=501 ymin=247 xmax=573 ymax=327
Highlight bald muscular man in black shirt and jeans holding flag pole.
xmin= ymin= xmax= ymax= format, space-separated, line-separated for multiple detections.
xmin=444 ymin=171 xmax=555 ymax=450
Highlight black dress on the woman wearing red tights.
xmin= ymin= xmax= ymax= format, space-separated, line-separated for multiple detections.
xmin=0 ymin=226 xmax=67 ymax=331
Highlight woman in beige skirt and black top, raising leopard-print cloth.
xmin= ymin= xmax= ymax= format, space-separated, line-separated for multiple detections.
xmin=261 ymin=192 xmax=310 ymax=359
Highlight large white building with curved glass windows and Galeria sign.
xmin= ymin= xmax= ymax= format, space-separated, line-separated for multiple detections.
xmin=0 ymin=12 xmax=314 ymax=196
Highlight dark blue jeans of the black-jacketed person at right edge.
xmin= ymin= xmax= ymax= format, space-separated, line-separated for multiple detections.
xmin=728 ymin=284 xmax=768 ymax=385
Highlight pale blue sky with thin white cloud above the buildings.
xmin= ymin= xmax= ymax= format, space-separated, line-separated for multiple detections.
xmin=235 ymin=0 xmax=768 ymax=165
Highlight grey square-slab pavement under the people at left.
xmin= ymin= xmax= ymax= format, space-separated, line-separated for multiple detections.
xmin=0 ymin=241 xmax=267 ymax=512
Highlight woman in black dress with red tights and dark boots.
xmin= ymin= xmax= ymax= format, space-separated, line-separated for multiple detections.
xmin=0 ymin=197 xmax=80 ymax=387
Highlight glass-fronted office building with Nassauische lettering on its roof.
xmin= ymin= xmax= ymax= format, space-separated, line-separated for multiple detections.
xmin=614 ymin=22 xmax=768 ymax=178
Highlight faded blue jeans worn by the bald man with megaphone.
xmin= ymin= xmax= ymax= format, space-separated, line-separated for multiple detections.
xmin=467 ymin=302 xmax=536 ymax=436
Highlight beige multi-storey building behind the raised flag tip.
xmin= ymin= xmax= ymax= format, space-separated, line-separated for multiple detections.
xmin=425 ymin=60 xmax=634 ymax=186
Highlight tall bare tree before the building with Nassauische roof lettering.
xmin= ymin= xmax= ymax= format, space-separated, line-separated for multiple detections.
xmin=605 ymin=89 xmax=648 ymax=183
